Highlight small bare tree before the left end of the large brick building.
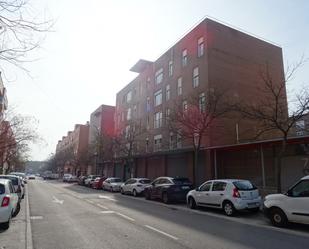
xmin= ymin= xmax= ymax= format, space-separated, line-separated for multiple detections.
xmin=114 ymin=120 xmax=145 ymax=177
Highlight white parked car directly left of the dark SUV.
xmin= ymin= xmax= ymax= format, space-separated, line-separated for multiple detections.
xmin=120 ymin=178 xmax=151 ymax=196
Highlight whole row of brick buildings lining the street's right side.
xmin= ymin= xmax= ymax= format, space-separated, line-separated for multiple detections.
xmin=56 ymin=18 xmax=309 ymax=193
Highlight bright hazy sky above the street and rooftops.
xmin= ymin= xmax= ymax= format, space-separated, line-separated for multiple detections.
xmin=4 ymin=0 xmax=309 ymax=160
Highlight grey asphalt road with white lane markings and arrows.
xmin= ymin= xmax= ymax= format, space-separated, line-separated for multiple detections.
xmin=25 ymin=180 xmax=309 ymax=249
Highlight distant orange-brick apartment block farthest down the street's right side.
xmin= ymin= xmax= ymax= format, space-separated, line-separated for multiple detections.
xmin=56 ymin=123 xmax=89 ymax=175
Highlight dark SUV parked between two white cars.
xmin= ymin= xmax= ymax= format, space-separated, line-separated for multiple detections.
xmin=144 ymin=176 xmax=193 ymax=203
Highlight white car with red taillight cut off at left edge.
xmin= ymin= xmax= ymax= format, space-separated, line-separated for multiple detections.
xmin=0 ymin=179 xmax=20 ymax=229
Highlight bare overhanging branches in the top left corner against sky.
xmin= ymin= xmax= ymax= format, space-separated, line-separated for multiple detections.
xmin=0 ymin=0 xmax=52 ymax=69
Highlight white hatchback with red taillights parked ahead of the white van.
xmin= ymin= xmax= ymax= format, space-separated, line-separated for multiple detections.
xmin=187 ymin=179 xmax=261 ymax=216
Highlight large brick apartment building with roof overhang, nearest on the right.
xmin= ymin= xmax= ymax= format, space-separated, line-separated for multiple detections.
xmin=115 ymin=18 xmax=287 ymax=182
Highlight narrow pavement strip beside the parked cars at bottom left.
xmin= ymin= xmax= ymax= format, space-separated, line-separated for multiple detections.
xmin=0 ymin=188 xmax=27 ymax=249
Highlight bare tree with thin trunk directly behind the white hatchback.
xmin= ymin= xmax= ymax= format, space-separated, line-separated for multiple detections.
xmin=168 ymin=89 xmax=230 ymax=183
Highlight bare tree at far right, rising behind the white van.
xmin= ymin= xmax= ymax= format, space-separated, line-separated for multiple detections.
xmin=235 ymin=59 xmax=309 ymax=192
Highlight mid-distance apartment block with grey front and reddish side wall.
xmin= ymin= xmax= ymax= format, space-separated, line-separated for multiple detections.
xmin=87 ymin=105 xmax=115 ymax=175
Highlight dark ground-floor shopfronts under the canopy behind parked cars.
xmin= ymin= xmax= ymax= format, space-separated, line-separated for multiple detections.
xmin=102 ymin=136 xmax=309 ymax=193
